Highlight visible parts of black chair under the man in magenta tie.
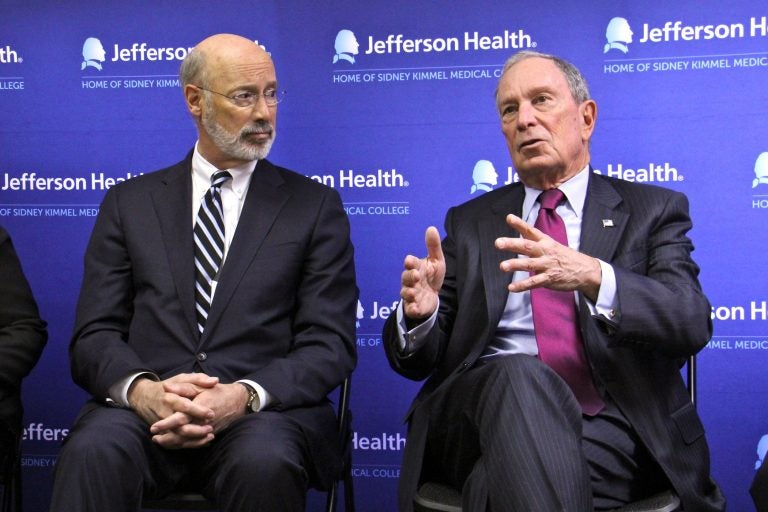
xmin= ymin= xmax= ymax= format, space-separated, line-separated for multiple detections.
xmin=413 ymin=355 xmax=696 ymax=512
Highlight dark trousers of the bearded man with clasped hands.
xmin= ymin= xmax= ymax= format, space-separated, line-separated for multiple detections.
xmin=50 ymin=404 xmax=308 ymax=512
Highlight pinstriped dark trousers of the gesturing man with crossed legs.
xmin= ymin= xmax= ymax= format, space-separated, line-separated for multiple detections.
xmin=426 ymin=355 xmax=668 ymax=512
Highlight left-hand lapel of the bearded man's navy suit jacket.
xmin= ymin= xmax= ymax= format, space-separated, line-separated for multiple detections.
xmin=152 ymin=153 xmax=198 ymax=346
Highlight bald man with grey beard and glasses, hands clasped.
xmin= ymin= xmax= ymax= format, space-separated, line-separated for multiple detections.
xmin=51 ymin=34 xmax=358 ymax=512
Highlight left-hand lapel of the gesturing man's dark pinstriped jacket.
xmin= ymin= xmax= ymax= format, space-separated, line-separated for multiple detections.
xmin=477 ymin=184 xmax=525 ymax=332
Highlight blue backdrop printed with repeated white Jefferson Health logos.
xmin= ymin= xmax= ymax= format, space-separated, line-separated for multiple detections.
xmin=0 ymin=0 xmax=768 ymax=511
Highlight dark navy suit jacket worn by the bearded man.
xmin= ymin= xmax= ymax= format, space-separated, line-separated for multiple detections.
xmin=70 ymin=153 xmax=358 ymax=483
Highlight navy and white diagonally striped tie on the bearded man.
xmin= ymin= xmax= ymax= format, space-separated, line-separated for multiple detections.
xmin=194 ymin=171 xmax=232 ymax=334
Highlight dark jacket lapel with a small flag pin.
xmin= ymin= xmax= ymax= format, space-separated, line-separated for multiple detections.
xmin=579 ymin=168 xmax=629 ymax=261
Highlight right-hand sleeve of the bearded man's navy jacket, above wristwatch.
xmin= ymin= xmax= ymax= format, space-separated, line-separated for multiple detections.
xmin=252 ymin=189 xmax=358 ymax=409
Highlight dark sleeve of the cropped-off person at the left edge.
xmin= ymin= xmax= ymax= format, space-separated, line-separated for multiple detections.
xmin=0 ymin=227 xmax=48 ymax=388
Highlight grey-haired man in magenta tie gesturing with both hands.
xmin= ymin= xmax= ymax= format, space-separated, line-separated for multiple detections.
xmin=384 ymin=52 xmax=724 ymax=512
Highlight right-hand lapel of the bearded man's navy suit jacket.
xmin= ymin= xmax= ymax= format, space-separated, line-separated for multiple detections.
xmin=200 ymin=160 xmax=291 ymax=345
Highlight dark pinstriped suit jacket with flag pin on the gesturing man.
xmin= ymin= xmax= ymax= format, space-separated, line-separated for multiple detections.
xmin=384 ymin=173 xmax=723 ymax=511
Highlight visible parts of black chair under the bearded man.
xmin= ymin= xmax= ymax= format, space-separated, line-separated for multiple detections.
xmin=141 ymin=377 xmax=355 ymax=512
